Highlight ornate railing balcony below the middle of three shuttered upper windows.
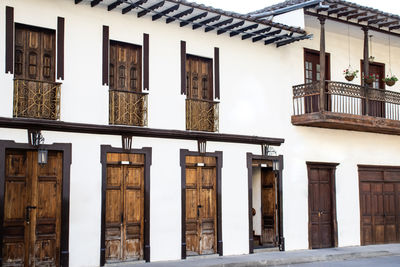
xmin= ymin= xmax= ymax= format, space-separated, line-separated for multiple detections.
xmin=109 ymin=90 xmax=147 ymax=126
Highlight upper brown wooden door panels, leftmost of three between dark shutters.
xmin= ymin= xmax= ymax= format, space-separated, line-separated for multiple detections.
xmin=15 ymin=24 xmax=55 ymax=82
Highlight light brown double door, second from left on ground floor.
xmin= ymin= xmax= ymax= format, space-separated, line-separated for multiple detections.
xmin=105 ymin=153 xmax=144 ymax=262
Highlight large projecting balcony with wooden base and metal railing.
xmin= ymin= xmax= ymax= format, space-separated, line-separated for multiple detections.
xmin=292 ymin=81 xmax=400 ymax=135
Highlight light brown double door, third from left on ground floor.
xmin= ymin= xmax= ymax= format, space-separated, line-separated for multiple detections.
xmin=186 ymin=156 xmax=217 ymax=256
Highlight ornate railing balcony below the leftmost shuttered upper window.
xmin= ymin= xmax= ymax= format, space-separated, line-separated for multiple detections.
xmin=13 ymin=79 xmax=61 ymax=120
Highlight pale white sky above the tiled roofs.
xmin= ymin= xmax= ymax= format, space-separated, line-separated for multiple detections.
xmin=194 ymin=0 xmax=400 ymax=15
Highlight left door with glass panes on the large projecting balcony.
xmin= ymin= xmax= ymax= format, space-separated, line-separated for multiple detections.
xmin=304 ymin=50 xmax=331 ymax=113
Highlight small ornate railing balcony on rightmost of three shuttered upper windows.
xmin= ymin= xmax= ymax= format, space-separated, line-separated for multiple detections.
xmin=186 ymin=99 xmax=219 ymax=132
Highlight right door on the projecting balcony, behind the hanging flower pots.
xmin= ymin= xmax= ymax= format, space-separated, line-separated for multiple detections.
xmin=361 ymin=60 xmax=386 ymax=118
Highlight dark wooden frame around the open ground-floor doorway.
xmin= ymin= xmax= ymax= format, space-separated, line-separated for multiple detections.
xmin=246 ymin=153 xmax=285 ymax=254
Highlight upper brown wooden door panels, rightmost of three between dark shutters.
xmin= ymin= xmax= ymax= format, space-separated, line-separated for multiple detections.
xmin=186 ymin=55 xmax=213 ymax=100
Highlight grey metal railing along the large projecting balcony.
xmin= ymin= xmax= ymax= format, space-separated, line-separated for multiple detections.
xmin=293 ymin=81 xmax=400 ymax=120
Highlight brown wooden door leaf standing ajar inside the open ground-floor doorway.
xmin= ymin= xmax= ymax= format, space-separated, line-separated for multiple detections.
xmin=261 ymin=168 xmax=277 ymax=246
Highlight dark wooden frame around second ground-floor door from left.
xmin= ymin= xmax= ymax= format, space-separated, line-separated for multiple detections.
xmin=100 ymin=145 xmax=152 ymax=266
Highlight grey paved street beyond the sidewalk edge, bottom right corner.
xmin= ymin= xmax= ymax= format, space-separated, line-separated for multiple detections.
xmin=290 ymin=256 xmax=400 ymax=267
